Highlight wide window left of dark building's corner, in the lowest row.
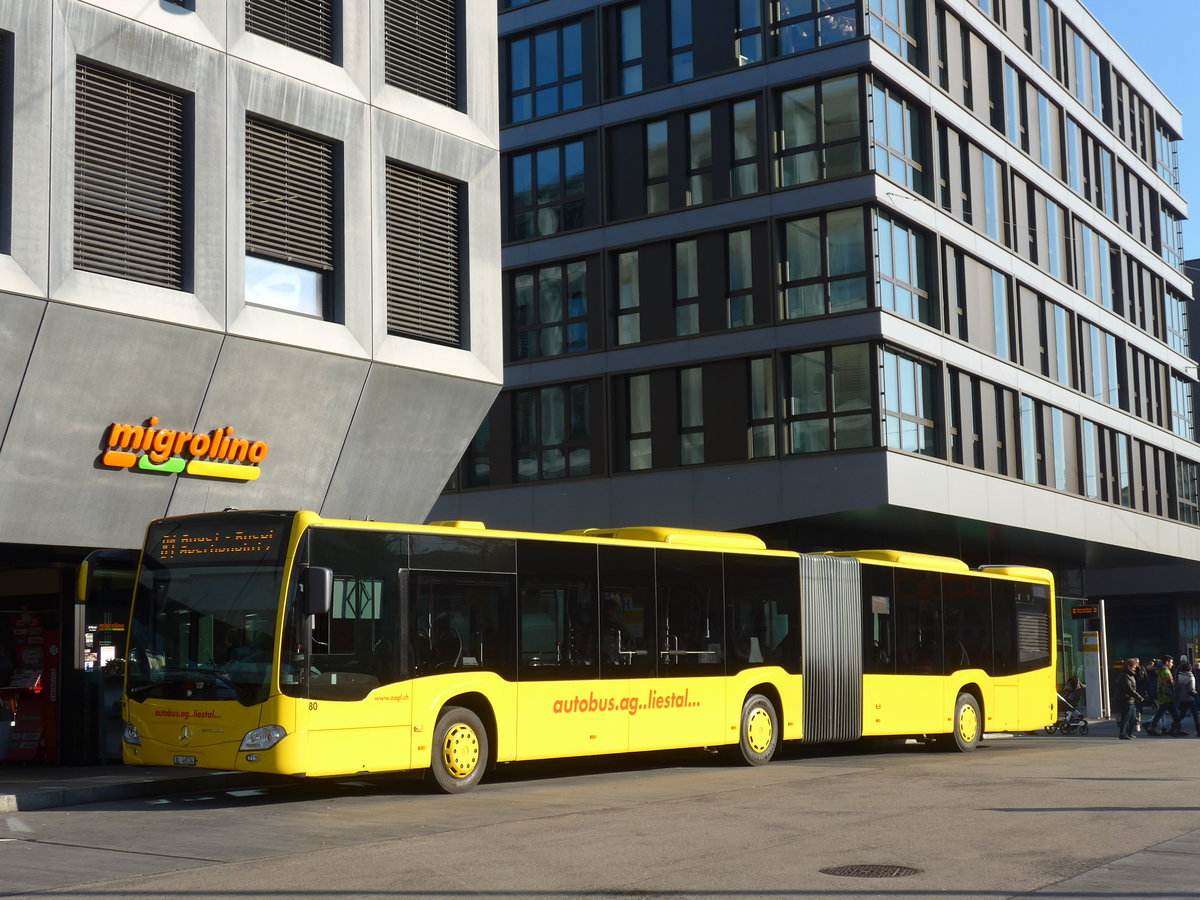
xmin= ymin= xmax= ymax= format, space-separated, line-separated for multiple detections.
xmin=787 ymin=343 xmax=874 ymax=454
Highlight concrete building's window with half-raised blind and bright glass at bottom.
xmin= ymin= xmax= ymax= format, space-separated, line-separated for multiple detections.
xmin=246 ymin=116 xmax=337 ymax=318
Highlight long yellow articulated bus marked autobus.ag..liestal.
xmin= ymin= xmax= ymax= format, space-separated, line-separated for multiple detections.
xmin=122 ymin=511 xmax=1057 ymax=792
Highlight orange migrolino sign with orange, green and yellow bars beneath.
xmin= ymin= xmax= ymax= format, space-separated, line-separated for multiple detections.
xmin=101 ymin=415 xmax=270 ymax=481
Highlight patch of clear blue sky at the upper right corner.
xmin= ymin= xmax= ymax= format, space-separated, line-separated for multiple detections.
xmin=1082 ymin=0 xmax=1200 ymax=259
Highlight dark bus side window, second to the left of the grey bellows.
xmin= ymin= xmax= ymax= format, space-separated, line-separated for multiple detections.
xmin=655 ymin=550 xmax=725 ymax=676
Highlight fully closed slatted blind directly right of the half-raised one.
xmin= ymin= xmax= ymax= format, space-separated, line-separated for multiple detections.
xmin=388 ymin=162 xmax=462 ymax=347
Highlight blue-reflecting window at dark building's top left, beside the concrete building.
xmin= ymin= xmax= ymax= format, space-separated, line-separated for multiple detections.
xmin=509 ymin=22 xmax=583 ymax=122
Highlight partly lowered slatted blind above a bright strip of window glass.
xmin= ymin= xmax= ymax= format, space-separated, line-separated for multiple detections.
xmin=246 ymin=119 xmax=335 ymax=271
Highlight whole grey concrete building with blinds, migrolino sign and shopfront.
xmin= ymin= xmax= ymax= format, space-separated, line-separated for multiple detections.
xmin=0 ymin=0 xmax=503 ymax=760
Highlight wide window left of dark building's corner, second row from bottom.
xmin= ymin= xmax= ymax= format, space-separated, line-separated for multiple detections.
xmin=780 ymin=208 xmax=868 ymax=319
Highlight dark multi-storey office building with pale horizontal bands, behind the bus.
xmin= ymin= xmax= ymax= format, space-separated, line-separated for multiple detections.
xmin=433 ymin=0 xmax=1200 ymax=672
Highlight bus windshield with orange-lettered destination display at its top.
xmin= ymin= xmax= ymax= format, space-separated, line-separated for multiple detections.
xmin=126 ymin=514 xmax=290 ymax=706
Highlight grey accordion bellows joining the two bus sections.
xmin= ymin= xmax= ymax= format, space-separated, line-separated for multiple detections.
xmin=800 ymin=554 xmax=863 ymax=743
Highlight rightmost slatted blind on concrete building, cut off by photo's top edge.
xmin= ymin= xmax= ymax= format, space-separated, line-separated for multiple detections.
xmin=383 ymin=0 xmax=458 ymax=108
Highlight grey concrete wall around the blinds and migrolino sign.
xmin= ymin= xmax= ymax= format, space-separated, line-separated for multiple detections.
xmin=0 ymin=0 xmax=503 ymax=546
